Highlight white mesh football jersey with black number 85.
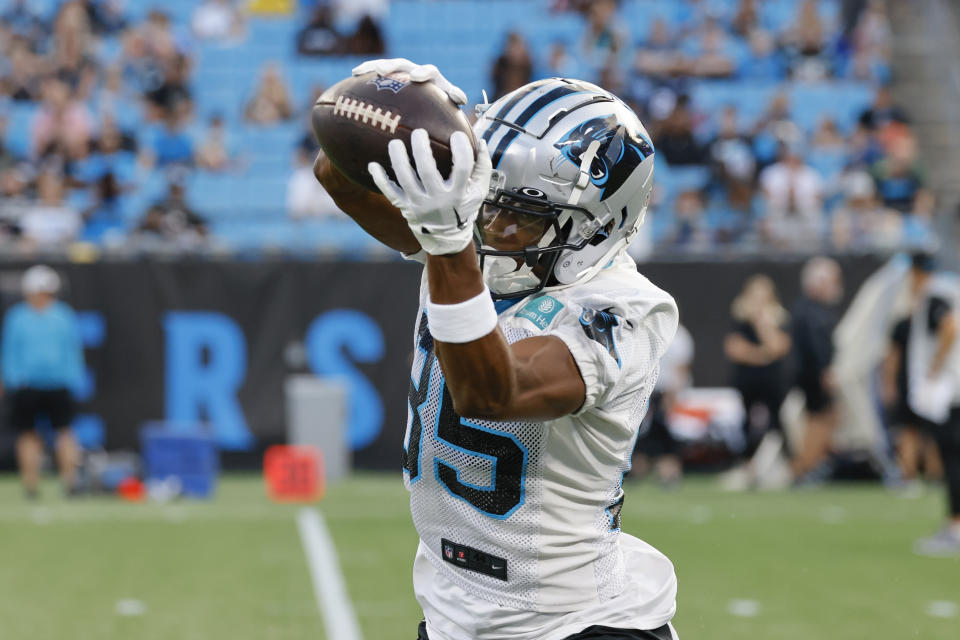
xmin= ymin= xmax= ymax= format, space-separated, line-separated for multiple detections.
xmin=403 ymin=254 xmax=678 ymax=640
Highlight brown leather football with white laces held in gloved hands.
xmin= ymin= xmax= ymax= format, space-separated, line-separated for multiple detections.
xmin=312 ymin=73 xmax=477 ymax=192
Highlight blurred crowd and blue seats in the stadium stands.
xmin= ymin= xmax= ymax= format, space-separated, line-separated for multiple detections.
xmin=0 ymin=0 xmax=936 ymax=255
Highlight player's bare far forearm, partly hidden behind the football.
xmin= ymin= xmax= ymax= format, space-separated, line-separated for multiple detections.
xmin=313 ymin=151 xmax=420 ymax=254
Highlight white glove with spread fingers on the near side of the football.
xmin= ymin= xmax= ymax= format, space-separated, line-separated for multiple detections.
xmin=367 ymin=129 xmax=491 ymax=256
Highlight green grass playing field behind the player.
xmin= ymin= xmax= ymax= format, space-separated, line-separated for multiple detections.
xmin=0 ymin=475 xmax=960 ymax=640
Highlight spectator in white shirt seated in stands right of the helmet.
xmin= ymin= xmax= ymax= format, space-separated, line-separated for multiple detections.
xmin=759 ymin=144 xmax=823 ymax=249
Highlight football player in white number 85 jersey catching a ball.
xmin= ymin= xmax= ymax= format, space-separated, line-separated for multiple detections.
xmin=315 ymin=60 xmax=677 ymax=640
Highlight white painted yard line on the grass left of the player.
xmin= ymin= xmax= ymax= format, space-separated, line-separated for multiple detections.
xmin=297 ymin=507 xmax=363 ymax=640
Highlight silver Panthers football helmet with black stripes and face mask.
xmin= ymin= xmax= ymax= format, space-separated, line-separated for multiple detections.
xmin=474 ymin=78 xmax=654 ymax=299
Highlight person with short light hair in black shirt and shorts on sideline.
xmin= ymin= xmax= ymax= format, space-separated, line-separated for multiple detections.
xmin=791 ymin=256 xmax=843 ymax=484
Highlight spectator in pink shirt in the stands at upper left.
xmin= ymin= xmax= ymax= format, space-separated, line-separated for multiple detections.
xmin=31 ymin=79 xmax=93 ymax=155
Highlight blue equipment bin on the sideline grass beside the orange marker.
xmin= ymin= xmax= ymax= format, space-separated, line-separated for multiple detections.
xmin=140 ymin=423 xmax=220 ymax=498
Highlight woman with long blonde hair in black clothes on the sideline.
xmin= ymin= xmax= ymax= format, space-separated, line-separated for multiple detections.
xmin=723 ymin=274 xmax=790 ymax=464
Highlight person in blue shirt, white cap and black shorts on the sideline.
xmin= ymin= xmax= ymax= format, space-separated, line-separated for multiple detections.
xmin=0 ymin=265 xmax=83 ymax=499
